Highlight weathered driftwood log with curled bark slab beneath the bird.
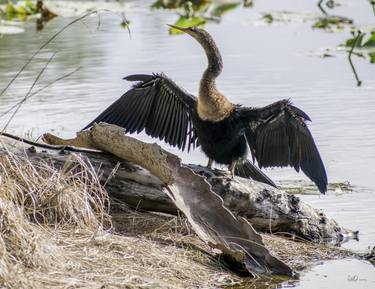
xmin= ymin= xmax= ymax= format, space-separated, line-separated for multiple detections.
xmin=0 ymin=124 xmax=358 ymax=275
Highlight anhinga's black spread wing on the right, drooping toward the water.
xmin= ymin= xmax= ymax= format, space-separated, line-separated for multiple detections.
xmin=242 ymin=100 xmax=328 ymax=194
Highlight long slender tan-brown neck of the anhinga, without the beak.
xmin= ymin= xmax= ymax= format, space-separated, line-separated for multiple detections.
xmin=198 ymin=35 xmax=232 ymax=121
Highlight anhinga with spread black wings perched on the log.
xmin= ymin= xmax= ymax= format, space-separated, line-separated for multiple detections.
xmin=84 ymin=25 xmax=327 ymax=193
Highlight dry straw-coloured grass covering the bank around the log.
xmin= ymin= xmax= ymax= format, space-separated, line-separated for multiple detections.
xmin=0 ymin=145 xmax=358 ymax=288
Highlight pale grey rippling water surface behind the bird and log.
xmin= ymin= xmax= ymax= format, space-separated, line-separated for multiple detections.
xmin=0 ymin=0 xmax=375 ymax=256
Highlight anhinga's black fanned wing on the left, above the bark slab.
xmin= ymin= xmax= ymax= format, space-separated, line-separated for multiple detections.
xmin=83 ymin=74 xmax=196 ymax=150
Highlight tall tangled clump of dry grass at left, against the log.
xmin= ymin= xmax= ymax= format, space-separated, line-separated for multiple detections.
xmin=0 ymin=152 xmax=110 ymax=229
